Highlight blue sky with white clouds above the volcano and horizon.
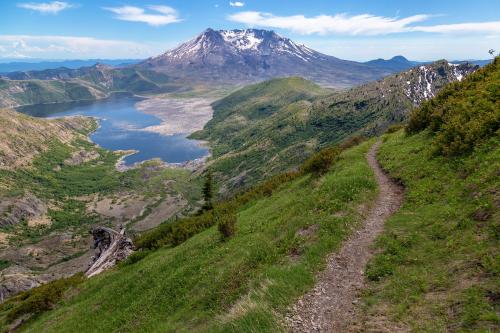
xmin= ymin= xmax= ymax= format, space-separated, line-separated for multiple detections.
xmin=0 ymin=0 xmax=500 ymax=60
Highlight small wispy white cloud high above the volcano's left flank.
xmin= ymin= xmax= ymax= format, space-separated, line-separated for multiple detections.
xmin=104 ymin=6 xmax=181 ymax=26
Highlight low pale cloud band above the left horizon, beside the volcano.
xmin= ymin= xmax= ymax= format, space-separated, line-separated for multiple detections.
xmin=0 ymin=35 xmax=173 ymax=59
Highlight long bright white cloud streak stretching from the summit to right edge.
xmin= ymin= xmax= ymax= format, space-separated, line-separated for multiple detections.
xmin=228 ymin=11 xmax=500 ymax=36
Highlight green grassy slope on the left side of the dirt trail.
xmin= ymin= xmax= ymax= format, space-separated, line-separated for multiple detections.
xmin=19 ymin=142 xmax=376 ymax=332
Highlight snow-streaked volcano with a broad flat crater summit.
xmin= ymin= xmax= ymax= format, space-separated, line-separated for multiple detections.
xmin=140 ymin=28 xmax=388 ymax=87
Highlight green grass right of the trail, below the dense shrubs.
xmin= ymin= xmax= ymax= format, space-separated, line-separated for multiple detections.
xmin=364 ymin=131 xmax=500 ymax=332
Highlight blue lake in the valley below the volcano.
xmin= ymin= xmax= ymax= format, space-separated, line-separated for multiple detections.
xmin=17 ymin=96 xmax=208 ymax=166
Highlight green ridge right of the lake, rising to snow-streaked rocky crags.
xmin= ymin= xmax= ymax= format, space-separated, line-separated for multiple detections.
xmin=193 ymin=61 xmax=477 ymax=193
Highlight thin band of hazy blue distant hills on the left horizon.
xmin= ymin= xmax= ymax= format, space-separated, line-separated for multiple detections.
xmin=0 ymin=59 xmax=142 ymax=73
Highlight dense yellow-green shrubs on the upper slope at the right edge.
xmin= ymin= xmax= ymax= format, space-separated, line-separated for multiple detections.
xmin=406 ymin=57 xmax=500 ymax=156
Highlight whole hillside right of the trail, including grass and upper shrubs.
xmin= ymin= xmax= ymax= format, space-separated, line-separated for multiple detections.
xmin=365 ymin=58 xmax=500 ymax=332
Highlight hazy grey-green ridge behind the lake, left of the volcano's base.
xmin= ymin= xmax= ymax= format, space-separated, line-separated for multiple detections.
xmin=0 ymin=64 xmax=184 ymax=107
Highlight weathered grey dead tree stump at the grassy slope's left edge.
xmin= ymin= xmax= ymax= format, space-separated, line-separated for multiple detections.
xmin=85 ymin=227 xmax=133 ymax=277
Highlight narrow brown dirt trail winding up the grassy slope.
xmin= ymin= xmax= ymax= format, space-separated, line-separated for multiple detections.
xmin=286 ymin=142 xmax=403 ymax=332
